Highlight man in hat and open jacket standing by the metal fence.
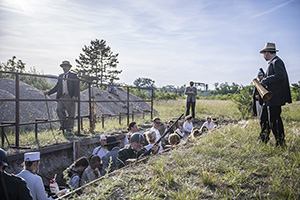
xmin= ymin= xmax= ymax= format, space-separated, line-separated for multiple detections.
xmin=44 ymin=61 xmax=79 ymax=133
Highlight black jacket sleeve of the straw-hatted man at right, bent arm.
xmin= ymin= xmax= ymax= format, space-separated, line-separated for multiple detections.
xmin=262 ymin=59 xmax=286 ymax=85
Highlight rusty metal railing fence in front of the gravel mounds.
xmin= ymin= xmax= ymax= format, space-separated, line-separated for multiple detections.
xmin=0 ymin=71 xmax=154 ymax=148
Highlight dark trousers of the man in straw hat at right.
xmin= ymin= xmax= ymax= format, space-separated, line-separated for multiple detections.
xmin=268 ymin=106 xmax=285 ymax=146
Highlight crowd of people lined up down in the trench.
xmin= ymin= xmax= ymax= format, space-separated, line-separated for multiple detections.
xmin=0 ymin=116 xmax=218 ymax=200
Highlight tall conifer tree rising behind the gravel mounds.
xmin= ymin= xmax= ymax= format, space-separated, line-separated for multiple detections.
xmin=74 ymin=39 xmax=122 ymax=87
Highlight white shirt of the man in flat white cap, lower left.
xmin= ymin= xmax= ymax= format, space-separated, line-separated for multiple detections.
xmin=17 ymin=169 xmax=52 ymax=200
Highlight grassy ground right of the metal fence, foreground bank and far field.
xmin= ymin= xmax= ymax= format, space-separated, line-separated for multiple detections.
xmin=61 ymin=101 xmax=300 ymax=200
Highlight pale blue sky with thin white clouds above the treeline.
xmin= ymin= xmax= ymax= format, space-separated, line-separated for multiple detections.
xmin=0 ymin=0 xmax=300 ymax=89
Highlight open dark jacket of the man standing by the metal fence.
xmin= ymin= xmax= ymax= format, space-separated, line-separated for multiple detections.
xmin=48 ymin=72 xmax=79 ymax=99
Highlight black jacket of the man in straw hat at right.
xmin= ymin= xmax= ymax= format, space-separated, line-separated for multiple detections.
xmin=262 ymin=56 xmax=292 ymax=106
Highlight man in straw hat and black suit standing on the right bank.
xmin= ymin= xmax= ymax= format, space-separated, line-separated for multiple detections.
xmin=260 ymin=42 xmax=292 ymax=147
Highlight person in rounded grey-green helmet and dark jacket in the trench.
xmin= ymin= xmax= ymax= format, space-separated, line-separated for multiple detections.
xmin=117 ymin=133 xmax=147 ymax=168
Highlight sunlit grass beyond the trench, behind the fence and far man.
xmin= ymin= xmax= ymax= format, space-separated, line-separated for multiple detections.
xmin=4 ymin=100 xmax=300 ymax=148
